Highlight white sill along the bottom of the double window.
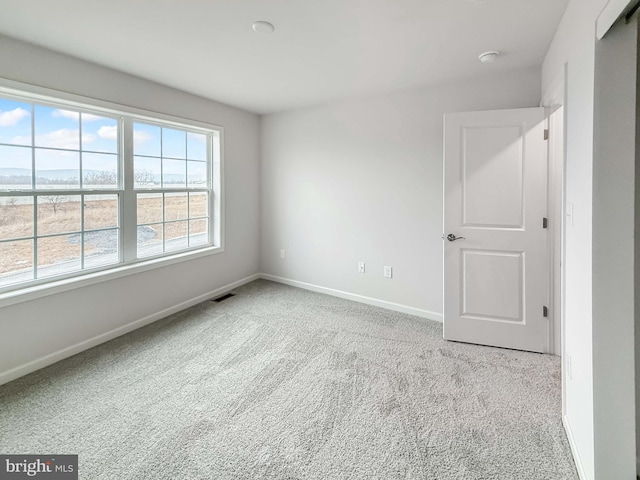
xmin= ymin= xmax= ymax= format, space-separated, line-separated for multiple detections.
xmin=0 ymin=246 xmax=224 ymax=308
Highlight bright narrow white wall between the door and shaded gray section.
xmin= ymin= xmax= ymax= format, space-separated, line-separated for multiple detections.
xmin=542 ymin=0 xmax=606 ymax=479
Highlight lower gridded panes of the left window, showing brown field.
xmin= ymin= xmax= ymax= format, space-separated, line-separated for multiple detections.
xmin=0 ymin=187 xmax=120 ymax=288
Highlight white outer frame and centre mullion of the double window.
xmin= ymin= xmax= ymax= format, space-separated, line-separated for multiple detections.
xmin=0 ymin=78 xmax=225 ymax=308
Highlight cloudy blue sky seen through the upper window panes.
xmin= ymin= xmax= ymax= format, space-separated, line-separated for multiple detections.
xmin=0 ymin=98 xmax=207 ymax=187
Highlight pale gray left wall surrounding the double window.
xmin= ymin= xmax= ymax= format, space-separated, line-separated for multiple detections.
xmin=0 ymin=36 xmax=260 ymax=380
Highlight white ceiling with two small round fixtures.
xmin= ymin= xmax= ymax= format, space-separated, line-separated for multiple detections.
xmin=0 ymin=0 xmax=568 ymax=113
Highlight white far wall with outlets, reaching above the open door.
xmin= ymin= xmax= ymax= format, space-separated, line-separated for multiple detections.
xmin=261 ymin=70 xmax=540 ymax=319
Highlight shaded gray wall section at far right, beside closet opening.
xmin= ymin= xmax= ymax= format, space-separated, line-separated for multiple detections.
xmin=593 ymin=14 xmax=638 ymax=479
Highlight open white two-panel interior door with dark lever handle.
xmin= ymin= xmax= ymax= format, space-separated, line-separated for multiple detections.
xmin=443 ymin=108 xmax=549 ymax=352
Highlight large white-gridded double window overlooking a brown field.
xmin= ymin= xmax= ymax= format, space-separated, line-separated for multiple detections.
xmin=0 ymin=91 xmax=221 ymax=293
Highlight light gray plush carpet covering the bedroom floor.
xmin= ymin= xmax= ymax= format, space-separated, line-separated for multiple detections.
xmin=0 ymin=280 xmax=577 ymax=480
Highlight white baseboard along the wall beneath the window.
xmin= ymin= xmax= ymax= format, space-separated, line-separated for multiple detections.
xmin=0 ymin=274 xmax=260 ymax=385
